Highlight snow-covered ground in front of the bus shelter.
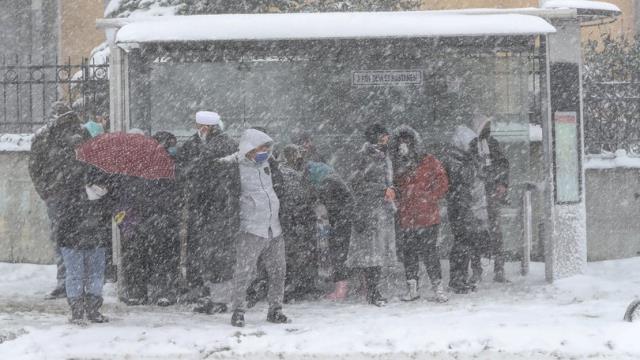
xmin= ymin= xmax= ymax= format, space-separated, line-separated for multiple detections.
xmin=0 ymin=258 xmax=640 ymax=359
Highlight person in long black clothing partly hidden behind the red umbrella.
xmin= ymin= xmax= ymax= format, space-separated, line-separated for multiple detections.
xmin=117 ymin=132 xmax=180 ymax=306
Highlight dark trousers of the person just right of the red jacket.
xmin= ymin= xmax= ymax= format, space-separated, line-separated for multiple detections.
xmin=449 ymin=231 xmax=490 ymax=287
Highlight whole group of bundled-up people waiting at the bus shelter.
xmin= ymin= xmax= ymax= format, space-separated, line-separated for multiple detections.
xmin=30 ymin=100 xmax=509 ymax=326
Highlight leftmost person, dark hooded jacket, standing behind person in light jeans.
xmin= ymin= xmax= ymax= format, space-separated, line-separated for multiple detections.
xmin=28 ymin=102 xmax=90 ymax=299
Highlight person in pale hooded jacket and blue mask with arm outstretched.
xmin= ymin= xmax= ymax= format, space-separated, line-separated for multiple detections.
xmin=218 ymin=129 xmax=289 ymax=327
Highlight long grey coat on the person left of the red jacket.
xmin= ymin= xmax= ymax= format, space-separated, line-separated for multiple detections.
xmin=346 ymin=143 xmax=396 ymax=268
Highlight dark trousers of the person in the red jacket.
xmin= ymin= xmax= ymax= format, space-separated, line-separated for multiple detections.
xmin=401 ymin=225 xmax=442 ymax=283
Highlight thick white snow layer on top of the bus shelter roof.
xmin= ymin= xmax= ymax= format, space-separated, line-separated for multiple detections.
xmin=116 ymin=11 xmax=556 ymax=44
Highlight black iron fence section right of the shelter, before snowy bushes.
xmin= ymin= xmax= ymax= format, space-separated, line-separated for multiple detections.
xmin=584 ymin=78 xmax=640 ymax=154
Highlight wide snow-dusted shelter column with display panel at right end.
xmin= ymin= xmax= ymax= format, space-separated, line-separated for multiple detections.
xmin=543 ymin=18 xmax=587 ymax=281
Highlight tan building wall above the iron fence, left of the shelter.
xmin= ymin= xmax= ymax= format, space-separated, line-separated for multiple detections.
xmin=59 ymin=0 xmax=105 ymax=63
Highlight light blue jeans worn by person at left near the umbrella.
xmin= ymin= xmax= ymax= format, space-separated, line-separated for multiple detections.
xmin=62 ymin=247 xmax=106 ymax=299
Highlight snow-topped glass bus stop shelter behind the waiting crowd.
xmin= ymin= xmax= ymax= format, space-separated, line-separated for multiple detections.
xmin=98 ymin=1 xmax=618 ymax=294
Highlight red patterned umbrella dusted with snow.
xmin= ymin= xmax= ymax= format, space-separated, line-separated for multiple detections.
xmin=76 ymin=132 xmax=175 ymax=180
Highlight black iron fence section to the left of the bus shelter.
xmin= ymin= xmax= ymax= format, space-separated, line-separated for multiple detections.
xmin=0 ymin=57 xmax=109 ymax=133
